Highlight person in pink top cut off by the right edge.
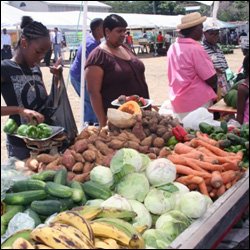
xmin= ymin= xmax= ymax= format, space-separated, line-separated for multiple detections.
xmin=236 ymin=55 xmax=249 ymax=124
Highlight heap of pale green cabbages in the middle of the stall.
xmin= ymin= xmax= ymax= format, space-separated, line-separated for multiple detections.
xmin=87 ymin=148 xmax=212 ymax=249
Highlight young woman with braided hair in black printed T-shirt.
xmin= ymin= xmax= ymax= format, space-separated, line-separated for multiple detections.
xmin=1 ymin=16 xmax=59 ymax=160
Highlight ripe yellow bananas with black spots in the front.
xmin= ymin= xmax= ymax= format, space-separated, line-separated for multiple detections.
xmin=1 ymin=207 xmax=145 ymax=249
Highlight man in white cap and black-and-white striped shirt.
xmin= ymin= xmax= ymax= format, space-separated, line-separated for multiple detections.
xmin=203 ymin=22 xmax=230 ymax=100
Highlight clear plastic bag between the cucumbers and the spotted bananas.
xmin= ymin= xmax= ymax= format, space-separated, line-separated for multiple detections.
xmin=1 ymin=213 xmax=35 ymax=244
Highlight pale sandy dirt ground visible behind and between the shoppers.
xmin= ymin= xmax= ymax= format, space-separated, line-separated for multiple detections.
xmin=1 ymin=49 xmax=243 ymax=163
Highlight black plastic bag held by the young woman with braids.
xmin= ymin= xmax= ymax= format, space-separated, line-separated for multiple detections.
xmin=42 ymin=75 xmax=78 ymax=148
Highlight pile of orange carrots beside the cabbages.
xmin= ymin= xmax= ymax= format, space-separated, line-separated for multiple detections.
xmin=167 ymin=132 xmax=244 ymax=199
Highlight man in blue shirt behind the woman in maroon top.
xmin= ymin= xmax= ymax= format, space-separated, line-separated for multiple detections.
xmin=70 ymin=18 xmax=104 ymax=125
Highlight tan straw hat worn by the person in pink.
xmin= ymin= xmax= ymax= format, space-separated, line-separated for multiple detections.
xmin=177 ymin=12 xmax=207 ymax=30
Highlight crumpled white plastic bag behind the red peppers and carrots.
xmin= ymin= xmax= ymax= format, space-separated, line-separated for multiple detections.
xmin=182 ymin=107 xmax=220 ymax=130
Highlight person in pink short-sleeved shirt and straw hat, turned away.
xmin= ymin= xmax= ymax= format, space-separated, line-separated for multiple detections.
xmin=167 ymin=12 xmax=217 ymax=120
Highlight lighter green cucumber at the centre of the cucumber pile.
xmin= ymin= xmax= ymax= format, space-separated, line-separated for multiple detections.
xmin=45 ymin=182 xmax=73 ymax=198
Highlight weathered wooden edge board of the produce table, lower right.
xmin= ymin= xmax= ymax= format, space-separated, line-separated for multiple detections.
xmin=169 ymin=170 xmax=249 ymax=249
